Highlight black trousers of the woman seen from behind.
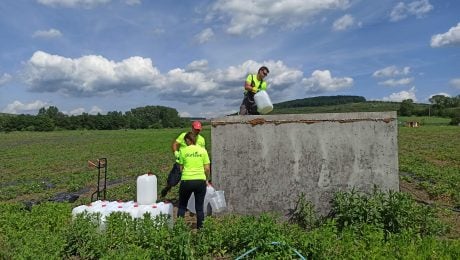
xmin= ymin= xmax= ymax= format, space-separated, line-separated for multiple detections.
xmin=177 ymin=180 xmax=206 ymax=228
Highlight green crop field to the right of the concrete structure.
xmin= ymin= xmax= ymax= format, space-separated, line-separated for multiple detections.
xmin=398 ymin=126 xmax=460 ymax=207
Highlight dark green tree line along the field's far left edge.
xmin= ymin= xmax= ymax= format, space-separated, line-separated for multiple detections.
xmin=0 ymin=106 xmax=190 ymax=132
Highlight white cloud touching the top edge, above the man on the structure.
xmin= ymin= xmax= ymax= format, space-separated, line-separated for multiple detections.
xmin=209 ymin=0 xmax=350 ymax=37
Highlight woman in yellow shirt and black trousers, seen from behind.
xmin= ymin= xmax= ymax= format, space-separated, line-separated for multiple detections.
xmin=177 ymin=132 xmax=211 ymax=229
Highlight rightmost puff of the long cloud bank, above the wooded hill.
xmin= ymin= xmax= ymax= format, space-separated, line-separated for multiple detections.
xmin=303 ymin=70 xmax=353 ymax=93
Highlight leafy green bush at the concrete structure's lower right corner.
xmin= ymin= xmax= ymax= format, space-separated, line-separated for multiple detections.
xmin=331 ymin=189 xmax=447 ymax=236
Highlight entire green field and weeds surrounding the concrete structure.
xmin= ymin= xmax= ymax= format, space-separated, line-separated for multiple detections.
xmin=0 ymin=119 xmax=460 ymax=259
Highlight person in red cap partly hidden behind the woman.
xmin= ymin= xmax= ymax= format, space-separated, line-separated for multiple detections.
xmin=160 ymin=121 xmax=206 ymax=197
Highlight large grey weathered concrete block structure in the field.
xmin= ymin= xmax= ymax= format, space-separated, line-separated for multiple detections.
xmin=211 ymin=112 xmax=399 ymax=215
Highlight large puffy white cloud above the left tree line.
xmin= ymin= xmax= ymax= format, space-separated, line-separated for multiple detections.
xmin=23 ymin=51 xmax=161 ymax=96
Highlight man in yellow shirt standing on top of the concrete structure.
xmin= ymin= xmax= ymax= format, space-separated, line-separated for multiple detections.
xmin=239 ymin=66 xmax=270 ymax=115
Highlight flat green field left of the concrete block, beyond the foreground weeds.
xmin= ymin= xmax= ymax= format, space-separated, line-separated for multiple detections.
xmin=0 ymin=129 xmax=210 ymax=201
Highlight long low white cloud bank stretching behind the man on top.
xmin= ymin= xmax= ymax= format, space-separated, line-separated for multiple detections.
xmin=22 ymin=51 xmax=353 ymax=105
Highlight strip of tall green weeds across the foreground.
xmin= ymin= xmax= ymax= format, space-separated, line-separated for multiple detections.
xmin=0 ymin=192 xmax=460 ymax=259
